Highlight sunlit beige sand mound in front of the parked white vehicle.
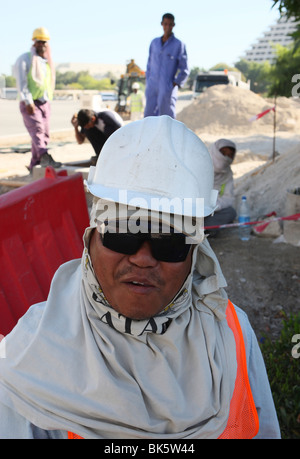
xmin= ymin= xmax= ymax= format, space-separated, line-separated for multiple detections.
xmin=177 ymin=85 xmax=300 ymax=136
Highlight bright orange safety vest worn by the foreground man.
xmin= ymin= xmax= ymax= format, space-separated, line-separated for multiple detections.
xmin=68 ymin=301 xmax=259 ymax=440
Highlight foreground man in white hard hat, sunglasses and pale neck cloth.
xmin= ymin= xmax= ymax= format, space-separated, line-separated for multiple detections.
xmin=0 ymin=116 xmax=280 ymax=441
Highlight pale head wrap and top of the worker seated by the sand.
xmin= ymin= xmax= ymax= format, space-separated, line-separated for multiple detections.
xmin=209 ymin=139 xmax=236 ymax=211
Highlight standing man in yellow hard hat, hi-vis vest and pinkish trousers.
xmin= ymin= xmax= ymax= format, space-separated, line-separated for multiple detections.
xmin=14 ymin=27 xmax=61 ymax=172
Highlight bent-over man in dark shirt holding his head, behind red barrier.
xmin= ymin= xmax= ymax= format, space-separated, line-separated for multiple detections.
xmin=71 ymin=109 xmax=123 ymax=163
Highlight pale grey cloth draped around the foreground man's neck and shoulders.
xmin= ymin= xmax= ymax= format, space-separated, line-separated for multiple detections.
xmin=0 ymin=228 xmax=236 ymax=439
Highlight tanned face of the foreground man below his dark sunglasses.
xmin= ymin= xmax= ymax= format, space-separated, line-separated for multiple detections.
xmin=90 ymin=230 xmax=192 ymax=320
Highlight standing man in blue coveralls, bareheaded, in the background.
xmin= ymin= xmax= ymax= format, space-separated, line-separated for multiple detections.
xmin=144 ymin=13 xmax=189 ymax=118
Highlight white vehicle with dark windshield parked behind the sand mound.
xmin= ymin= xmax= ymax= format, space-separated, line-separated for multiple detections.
xmin=193 ymin=69 xmax=250 ymax=98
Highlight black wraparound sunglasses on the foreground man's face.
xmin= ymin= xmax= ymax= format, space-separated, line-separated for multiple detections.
xmin=100 ymin=231 xmax=191 ymax=263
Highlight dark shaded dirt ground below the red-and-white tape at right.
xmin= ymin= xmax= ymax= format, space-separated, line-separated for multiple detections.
xmin=210 ymin=228 xmax=300 ymax=340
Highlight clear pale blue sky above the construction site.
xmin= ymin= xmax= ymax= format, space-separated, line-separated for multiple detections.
xmin=0 ymin=0 xmax=279 ymax=75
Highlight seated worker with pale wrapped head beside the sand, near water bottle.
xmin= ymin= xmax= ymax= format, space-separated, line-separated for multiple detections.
xmin=204 ymin=139 xmax=236 ymax=235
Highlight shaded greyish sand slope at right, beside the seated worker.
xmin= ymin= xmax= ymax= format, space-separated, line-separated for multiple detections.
xmin=235 ymin=145 xmax=300 ymax=218
